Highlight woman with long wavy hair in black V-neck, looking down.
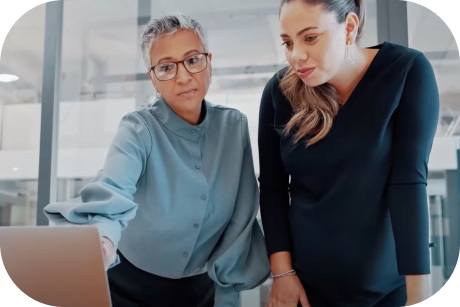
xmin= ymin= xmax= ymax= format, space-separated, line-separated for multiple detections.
xmin=258 ymin=0 xmax=439 ymax=307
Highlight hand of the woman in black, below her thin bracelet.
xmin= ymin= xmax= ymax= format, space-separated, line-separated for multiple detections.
xmin=267 ymin=275 xmax=311 ymax=307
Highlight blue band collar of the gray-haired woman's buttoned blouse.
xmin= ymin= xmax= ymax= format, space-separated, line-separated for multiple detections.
xmin=152 ymin=99 xmax=211 ymax=141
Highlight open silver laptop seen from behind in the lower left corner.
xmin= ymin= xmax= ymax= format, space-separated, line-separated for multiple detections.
xmin=0 ymin=226 xmax=111 ymax=307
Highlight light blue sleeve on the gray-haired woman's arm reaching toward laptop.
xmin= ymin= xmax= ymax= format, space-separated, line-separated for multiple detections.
xmin=44 ymin=113 xmax=152 ymax=247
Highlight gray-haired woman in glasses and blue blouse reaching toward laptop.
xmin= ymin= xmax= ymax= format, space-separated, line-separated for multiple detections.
xmin=45 ymin=14 xmax=269 ymax=307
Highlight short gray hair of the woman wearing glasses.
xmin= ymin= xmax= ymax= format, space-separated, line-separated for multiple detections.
xmin=141 ymin=13 xmax=208 ymax=69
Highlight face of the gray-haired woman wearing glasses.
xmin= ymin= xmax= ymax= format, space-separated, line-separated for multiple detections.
xmin=149 ymin=30 xmax=211 ymax=118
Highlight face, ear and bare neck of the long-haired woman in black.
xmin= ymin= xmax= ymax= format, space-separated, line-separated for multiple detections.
xmin=280 ymin=1 xmax=378 ymax=103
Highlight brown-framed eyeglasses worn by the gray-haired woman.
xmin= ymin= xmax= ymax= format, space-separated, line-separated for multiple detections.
xmin=150 ymin=52 xmax=209 ymax=81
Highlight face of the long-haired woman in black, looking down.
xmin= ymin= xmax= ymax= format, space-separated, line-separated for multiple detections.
xmin=280 ymin=0 xmax=347 ymax=87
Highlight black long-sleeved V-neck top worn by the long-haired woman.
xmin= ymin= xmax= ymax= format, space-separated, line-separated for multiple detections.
xmin=258 ymin=42 xmax=439 ymax=306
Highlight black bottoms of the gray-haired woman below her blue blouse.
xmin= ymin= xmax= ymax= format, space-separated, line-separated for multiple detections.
xmin=107 ymin=253 xmax=215 ymax=307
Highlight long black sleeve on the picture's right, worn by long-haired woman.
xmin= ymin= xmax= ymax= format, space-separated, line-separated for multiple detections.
xmin=386 ymin=54 xmax=439 ymax=275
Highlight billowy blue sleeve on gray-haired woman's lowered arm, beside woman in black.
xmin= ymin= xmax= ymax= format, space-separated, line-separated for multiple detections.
xmin=208 ymin=116 xmax=270 ymax=307
